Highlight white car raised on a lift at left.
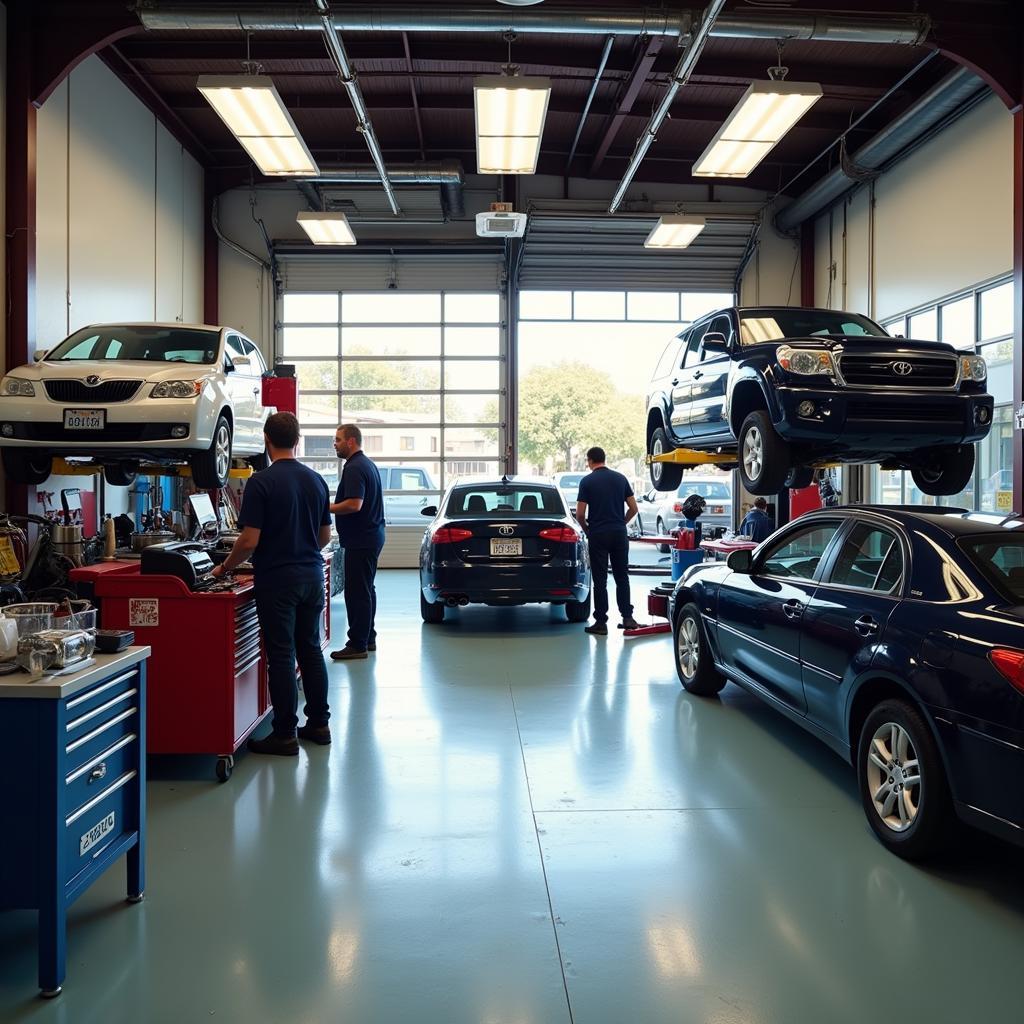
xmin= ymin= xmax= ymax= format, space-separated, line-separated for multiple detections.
xmin=0 ymin=324 xmax=272 ymax=489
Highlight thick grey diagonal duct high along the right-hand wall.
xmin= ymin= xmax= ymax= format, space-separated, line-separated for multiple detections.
xmin=775 ymin=68 xmax=989 ymax=233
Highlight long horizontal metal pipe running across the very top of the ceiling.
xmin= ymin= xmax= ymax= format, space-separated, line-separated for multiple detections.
xmin=134 ymin=0 xmax=931 ymax=46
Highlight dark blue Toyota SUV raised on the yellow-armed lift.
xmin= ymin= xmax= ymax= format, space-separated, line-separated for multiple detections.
xmin=647 ymin=306 xmax=992 ymax=495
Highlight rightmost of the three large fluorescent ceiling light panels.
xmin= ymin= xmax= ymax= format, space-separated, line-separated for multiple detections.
xmin=692 ymin=80 xmax=821 ymax=178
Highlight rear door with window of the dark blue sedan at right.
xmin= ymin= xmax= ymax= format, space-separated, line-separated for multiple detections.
xmin=800 ymin=522 xmax=906 ymax=736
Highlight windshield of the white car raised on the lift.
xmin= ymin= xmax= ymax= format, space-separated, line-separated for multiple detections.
xmin=46 ymin=325 xmax=220 ymax=365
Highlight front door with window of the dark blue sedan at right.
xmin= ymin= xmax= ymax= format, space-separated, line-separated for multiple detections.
xmin=718 ymin=518 xmax=842 ymax=713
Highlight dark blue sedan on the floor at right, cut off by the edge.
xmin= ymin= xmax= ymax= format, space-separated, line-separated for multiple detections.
xmin=670 ymin=506 xmax=1024 ymax=859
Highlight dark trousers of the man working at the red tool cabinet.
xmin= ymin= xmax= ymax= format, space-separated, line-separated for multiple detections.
xmin=256 ymin=579 xmax=331 ymax=736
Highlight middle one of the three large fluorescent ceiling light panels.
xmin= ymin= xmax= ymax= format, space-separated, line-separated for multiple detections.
xmin=473 ymin=75 xmax=551 ymax=174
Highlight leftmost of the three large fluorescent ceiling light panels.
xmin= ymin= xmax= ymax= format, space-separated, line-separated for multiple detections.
xmin=197 ymin=75 xmax=319 ymax=177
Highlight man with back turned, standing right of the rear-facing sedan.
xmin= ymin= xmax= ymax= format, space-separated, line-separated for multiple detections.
xmin=577 ymin=447 xmax=637 ymax=636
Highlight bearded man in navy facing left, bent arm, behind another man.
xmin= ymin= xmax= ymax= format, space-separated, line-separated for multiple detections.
xmin=331 ymin=423 xmax=384 ymax=662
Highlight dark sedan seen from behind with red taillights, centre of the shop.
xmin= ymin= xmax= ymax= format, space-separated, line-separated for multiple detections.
xmin=420 ymin=477 xmax=590 ymax=623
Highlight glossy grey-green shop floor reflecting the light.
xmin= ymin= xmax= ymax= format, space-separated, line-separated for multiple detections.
xmin=0 ymin=570 xmax=1024 ymax=1024
